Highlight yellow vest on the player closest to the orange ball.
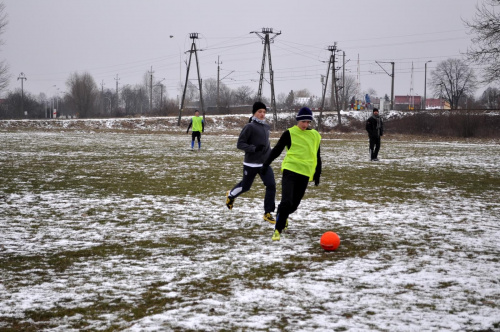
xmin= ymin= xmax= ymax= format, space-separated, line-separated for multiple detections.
xmin=281 ymin=126 xmax=321 ymax=181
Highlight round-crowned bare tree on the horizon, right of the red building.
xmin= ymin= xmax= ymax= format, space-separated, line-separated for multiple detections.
xmin=431 ymin=59 xmax=477 ymax=109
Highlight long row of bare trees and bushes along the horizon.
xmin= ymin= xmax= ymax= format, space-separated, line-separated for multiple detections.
xmin=0 ymin=63 xmax=500 ymax=119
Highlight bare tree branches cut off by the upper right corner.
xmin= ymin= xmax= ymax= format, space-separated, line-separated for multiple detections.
xmin=465 ymin=0 xmax=500 ymax=83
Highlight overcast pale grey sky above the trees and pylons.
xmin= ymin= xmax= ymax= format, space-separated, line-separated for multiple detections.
xmin=0 ymin=0 xmax=485 ymax=98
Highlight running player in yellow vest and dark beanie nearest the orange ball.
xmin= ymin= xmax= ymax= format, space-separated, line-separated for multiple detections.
xmin=262 ymin=107 xmax=321 ymax=241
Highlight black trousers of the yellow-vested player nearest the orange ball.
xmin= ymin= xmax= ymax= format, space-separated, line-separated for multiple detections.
xmin=275 ymin=169 xmax=309 ymax=233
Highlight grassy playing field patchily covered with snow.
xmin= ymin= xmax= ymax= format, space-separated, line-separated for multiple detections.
xmin=0 ymin=131 xmax=500 ymax=331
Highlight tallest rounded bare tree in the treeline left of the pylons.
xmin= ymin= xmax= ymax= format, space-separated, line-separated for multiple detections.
xmin=66 ymin=72 xmax=99 ymax=118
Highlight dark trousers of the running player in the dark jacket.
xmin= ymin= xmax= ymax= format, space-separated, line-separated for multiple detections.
xmin=229 ymin=165 xmax=276 ymax=213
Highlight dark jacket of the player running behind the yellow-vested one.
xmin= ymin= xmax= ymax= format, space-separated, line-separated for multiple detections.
xmin=236 ymin=120 xmax=271 ymax=164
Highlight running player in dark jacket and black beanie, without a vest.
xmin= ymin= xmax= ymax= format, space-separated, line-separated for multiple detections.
xmin=226 ymin=102 xmax=276 ymax=224
